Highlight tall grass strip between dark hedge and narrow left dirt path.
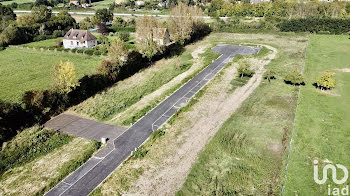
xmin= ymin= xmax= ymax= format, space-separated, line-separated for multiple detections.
xmin=73 ymin=51 xmax=193 ymax=121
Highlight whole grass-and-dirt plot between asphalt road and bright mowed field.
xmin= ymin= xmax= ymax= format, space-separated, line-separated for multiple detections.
xmin=87 ymin=33 xmax=308 ymax=195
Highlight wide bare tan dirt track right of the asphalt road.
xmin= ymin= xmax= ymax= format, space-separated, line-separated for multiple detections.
xmin=126 ymin=45 xmax=277 ymax=195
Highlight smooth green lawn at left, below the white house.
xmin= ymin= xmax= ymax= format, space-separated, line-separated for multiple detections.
xmin=0 ymin=48 xmax=101 ymax=102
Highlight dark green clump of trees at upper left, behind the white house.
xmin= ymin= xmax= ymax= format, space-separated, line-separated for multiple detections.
xmin=0 ymin=5 xmax=76 ymax=46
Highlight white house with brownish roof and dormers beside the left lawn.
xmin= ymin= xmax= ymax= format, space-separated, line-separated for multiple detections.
xmin=63 ymin=29 xmax=97 ymax=49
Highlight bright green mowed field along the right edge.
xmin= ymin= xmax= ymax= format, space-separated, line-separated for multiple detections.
xmin=284 ymin=35 xmax=350 ymax=195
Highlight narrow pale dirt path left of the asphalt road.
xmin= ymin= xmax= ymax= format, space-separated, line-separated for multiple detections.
xmin=109 ymin=44 xmax=209 ymax=124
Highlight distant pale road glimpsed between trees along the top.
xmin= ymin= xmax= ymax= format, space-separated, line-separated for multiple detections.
xmin=14 ymin=10 xmax=228 ymax=19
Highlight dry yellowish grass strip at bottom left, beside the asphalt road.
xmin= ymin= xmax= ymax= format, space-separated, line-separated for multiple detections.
xmin=0 ymin=138 xmax=98 ymax=196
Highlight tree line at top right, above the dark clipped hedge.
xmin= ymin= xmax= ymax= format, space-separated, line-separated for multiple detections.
xmin=204 ymin=0 xmax=350 ymax=19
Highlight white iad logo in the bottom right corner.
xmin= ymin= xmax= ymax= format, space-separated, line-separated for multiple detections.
xmin=314 ymin=160 xmax=349 ymax=195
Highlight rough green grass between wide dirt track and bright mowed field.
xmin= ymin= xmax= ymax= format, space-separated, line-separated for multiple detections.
xmin=177 ymin=34 xmax=307 ymax=195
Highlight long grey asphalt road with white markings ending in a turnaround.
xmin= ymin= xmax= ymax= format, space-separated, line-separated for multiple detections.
xmin=46 ymin=45 xmax=260 ymax=196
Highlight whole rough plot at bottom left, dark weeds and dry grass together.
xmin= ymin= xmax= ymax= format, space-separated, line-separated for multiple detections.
xmin=0 ymin=126 xmax=100 ymax=195
